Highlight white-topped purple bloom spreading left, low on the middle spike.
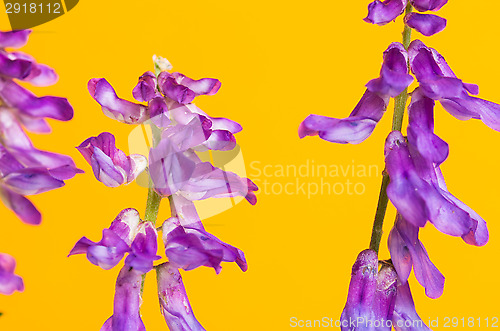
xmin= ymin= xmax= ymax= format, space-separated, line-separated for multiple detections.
xmin=68 ymin=208 xmax=160 ymax=273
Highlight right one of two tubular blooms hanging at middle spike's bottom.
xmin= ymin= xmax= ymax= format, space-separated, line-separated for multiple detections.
xmin=156 ymin=262 xmax=205 ymax=331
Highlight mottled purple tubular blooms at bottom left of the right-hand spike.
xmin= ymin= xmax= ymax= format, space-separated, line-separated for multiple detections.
xmin=340 ymin=249 xmax=397 ymax=331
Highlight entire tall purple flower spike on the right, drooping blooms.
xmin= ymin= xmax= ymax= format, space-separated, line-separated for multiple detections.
xmin=299 ymin=0 xmax=500 ymax=330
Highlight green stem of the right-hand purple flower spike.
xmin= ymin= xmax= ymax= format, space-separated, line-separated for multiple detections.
xmin=370 ymin=3 xmax=413 ymax=253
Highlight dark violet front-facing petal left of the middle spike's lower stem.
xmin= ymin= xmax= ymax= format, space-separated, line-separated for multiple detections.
xmin=125 ymin=222 xmax=161 ymax=273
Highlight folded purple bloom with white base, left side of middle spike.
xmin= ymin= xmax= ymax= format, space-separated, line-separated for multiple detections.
xmin=77 ymin=132 xmax=147 ymax=187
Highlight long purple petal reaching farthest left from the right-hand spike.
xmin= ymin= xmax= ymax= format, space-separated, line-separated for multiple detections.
xmin=299 ymin=90 xmax=389 ymax=144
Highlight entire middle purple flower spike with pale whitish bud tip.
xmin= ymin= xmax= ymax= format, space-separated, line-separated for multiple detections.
xmin=69 ymin=58 xmax=258 ymax=331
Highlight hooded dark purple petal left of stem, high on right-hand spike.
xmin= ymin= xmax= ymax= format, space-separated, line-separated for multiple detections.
xmin=366 ymin=43 xmax=413 ymax=98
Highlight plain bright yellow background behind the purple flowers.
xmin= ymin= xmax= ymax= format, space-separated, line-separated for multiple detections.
xmin=0 ymin=0 xmax=500 ymax=331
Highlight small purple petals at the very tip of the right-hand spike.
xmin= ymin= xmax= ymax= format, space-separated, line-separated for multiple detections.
xmin=365 ymin=0 xmax=448 ymax=36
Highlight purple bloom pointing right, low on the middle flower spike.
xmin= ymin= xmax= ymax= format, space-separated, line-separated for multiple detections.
xmin=162 ymin=217 xmax=247 ymax=273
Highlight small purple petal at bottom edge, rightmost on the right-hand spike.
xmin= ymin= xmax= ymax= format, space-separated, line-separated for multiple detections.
xmin=392 ymin=282 xmax=431 ymax=331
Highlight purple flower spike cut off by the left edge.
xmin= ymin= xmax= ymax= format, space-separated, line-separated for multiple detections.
xmin=0 ymin=30 xmax=81 ymax=294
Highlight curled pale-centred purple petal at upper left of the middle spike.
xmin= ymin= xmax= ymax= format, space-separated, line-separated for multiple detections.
xmin=87 ymin=78 xmax=148 ymax=124
